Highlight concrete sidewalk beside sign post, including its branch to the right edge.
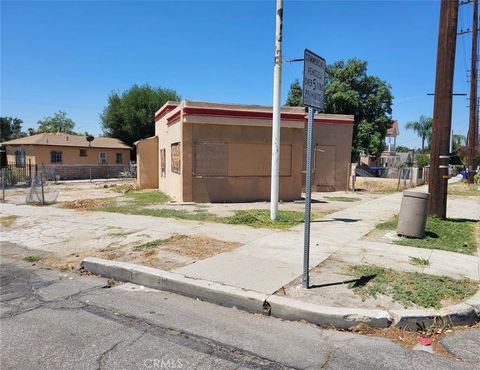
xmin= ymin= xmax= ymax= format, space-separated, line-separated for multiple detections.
xmin=175 ymin=186 xmax=480 ymax=294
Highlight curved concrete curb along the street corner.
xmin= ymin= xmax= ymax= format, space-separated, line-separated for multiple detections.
xmin=81 ymin=257 xmax=480 ymax=330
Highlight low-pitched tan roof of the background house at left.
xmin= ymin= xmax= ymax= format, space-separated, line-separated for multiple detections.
xmin=1 ymin=132 xmax=130 ymax=149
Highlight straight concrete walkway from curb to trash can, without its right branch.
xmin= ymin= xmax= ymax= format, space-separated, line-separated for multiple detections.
xmin=176 ymin=193 xmax=402 ymax=294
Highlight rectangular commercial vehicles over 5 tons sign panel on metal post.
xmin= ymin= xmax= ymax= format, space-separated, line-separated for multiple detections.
xmin=303 ymin=49 xmax=326 ymax=111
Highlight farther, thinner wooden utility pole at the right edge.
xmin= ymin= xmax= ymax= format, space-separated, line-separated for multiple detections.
xmin=467 ymin=0 xmax=478 ymax=184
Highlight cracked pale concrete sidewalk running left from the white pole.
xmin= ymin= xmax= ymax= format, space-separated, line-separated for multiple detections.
xmin=0 ymin=203 xmax=273 ymax=255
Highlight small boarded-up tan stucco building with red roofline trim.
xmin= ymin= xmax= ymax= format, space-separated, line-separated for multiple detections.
xmin=137 ymin=100 xmax=353 ymax=202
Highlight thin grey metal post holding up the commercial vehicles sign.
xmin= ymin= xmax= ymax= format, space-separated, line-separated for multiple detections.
xmin=303 ymin=107 xmax=313 ymax=289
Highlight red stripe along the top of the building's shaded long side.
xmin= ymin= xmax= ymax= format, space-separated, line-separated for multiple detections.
xmin=183 ymin=107 xmax=353 ymax=125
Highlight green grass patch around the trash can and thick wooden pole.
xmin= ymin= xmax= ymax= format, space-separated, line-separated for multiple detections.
xmin=376 ymin=216 xmax=479 ymax=254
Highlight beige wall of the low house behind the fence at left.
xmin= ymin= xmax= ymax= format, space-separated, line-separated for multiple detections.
xmin=6 ymin=145 xmax=130 ymax=165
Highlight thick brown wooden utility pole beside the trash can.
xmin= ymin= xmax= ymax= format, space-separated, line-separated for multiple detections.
xmin=428 ymin=0 xmax=458 ymax=219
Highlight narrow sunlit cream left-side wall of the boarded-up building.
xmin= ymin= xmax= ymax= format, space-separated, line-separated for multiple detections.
xmin=155 ymin=120 xmax=185 ymax=202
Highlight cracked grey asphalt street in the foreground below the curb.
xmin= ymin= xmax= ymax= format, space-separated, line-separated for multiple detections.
xmin=0 ymin=257 xmax=480 ymax=370
